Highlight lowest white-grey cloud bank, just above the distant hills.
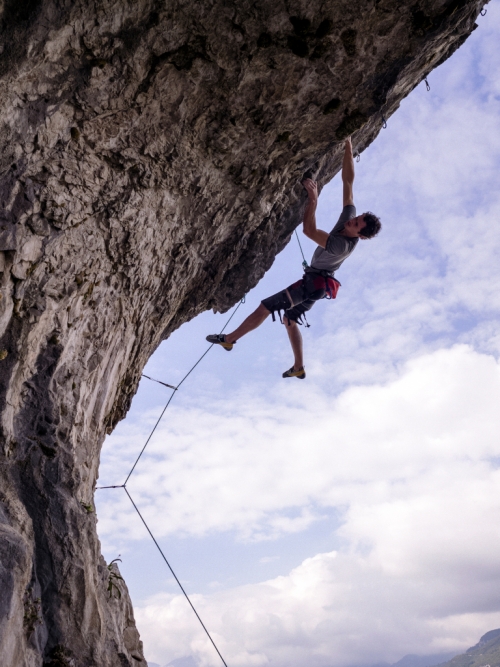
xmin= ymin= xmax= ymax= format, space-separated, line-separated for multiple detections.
xmin=136 ymin=552 xmax=500 ymax=667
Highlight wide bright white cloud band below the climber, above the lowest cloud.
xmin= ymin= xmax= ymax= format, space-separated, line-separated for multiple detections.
xmin=99 ymin=346 xmax=500 ymax=539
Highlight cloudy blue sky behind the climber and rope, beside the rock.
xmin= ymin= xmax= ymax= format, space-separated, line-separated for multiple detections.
xmin=96 ymin=7 xmax=500 ymax=667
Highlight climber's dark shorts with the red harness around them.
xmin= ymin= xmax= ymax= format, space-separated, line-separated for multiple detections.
xmin=261 ymin=271 xmax=340 ymax=324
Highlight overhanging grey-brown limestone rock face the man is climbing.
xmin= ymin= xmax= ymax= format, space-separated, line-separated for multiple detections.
xmin=0 ymin=0 xmax=483 ymax=667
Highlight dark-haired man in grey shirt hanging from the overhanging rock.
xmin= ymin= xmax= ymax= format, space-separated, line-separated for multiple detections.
xmin=207 ymin=138 xmax=381 ymax=380
